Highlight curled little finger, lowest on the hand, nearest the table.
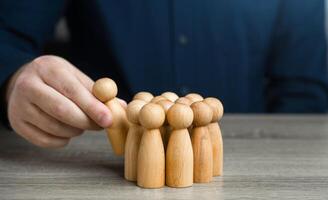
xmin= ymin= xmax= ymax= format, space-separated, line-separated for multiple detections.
xmin=16 ymin=122 xmax=69 ymax=148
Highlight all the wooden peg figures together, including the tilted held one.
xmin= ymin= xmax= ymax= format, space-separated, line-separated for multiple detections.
xmin=93 ymin=78 xmax=223 ymax=188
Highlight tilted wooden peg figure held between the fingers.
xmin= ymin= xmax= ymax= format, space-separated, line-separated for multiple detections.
xmin=92 ymin=78 xmax=129 ymax=155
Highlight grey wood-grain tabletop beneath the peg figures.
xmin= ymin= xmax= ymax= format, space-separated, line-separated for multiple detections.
xmin=0 ymin=115 xmax=328 ymax=200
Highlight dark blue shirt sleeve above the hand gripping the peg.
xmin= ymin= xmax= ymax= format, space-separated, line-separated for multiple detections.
xmin=0 ymin=0 xmax=68 ymax=126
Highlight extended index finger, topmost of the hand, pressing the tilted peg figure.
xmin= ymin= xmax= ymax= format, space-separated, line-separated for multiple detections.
xmin=40 ymin=63 xmax=112 ymax=127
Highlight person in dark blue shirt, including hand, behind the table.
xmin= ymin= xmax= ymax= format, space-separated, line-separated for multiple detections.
xmin=0 ymin=0 xmax=328 ymax=147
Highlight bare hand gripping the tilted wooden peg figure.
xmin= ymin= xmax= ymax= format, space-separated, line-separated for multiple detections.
xmin=6 ymin=56 xmax=124 ymax=148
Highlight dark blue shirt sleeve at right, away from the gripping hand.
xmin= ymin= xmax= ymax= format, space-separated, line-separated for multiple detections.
xmin=266 ymin=0 xmax=328 ymax=113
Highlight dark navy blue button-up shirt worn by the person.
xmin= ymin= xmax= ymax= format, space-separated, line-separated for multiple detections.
xmin=0 ymin=0 xmax=328 ymax=112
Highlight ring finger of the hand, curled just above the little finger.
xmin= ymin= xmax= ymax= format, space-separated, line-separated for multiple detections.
xmin=23 ymin=104 xmax=83 ymax=138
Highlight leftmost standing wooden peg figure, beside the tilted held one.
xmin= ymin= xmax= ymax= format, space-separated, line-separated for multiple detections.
xmin=124 ymin=99 xmax=146 ymax=181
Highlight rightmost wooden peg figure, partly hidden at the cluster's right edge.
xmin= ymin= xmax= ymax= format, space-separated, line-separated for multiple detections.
xmin=204 ymin=97 xmax=223 ymax=176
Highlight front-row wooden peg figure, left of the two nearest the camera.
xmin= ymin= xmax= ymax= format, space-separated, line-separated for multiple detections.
xmin=137 ymin=103 xmax=165 ymax=188
